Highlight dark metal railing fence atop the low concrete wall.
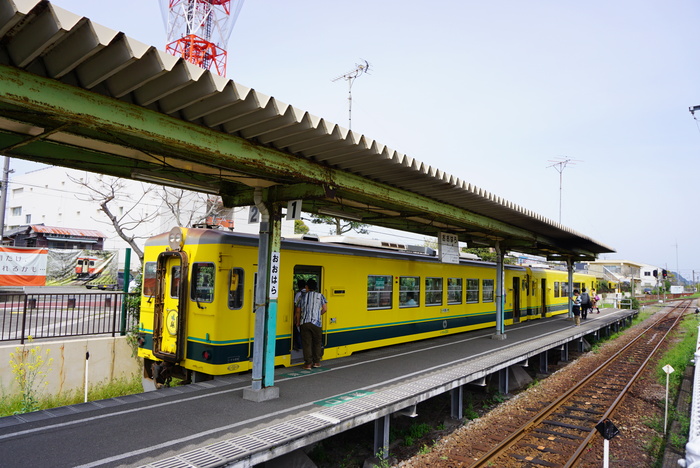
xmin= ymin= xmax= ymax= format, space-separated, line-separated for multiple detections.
xmin=0 ymin=292 xmax=133 ymax=344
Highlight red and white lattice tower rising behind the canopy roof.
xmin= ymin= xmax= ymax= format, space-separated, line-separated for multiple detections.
xmin=160 ymin=0 xmax=243 ymax=76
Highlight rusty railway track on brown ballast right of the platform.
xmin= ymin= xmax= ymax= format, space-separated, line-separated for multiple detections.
xmin=464 ymin=301 xmax=691 ymax=468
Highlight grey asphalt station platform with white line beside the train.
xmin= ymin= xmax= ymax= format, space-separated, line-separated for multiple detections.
xmin=0 ymin=309 xmax=637 ymax=468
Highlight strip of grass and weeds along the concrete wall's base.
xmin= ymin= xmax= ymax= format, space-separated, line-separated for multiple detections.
xmin=0 ymin=375 xmax=143 ymax=417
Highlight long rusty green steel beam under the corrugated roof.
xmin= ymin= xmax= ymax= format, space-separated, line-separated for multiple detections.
xmin=0 ymin=66 xmax=596 ymax=251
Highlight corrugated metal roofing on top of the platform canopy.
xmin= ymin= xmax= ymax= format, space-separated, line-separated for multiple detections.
xmin=0 ymin=0 xmax=613 ymax=253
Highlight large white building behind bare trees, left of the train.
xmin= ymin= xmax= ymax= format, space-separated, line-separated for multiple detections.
xmin=5 ymin=166 xmax=294 ymax=270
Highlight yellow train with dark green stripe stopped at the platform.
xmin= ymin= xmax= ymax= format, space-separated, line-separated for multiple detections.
xmin=139 ymin=228 xmax=595 ymax=383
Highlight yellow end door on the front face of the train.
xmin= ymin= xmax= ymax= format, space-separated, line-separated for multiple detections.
xmin=153 ymin=251 xmax=188 ymax=363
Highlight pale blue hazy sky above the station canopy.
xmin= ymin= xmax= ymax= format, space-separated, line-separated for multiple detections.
xmin=19 ymin=0 xmax=700 ymax=279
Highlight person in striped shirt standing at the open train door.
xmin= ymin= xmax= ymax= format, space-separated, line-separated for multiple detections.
xmin=294 ymin=279 xmax=328 ymax=369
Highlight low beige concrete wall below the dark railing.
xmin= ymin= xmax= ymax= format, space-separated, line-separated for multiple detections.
xmin=0 ymin=336 xmax=141 ymax=395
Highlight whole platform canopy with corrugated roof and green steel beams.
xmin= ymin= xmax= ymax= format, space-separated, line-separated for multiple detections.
xmin=0 ymin=0 xmax=613 ymax=260
